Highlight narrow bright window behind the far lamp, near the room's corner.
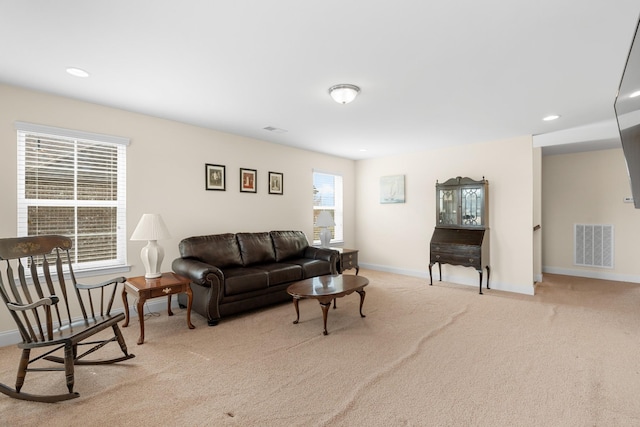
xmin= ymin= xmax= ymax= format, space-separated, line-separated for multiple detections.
xmin=313 ymin=171 xmax=344 ymax=244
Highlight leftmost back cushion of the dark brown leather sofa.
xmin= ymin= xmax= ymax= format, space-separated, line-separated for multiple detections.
xmin=178 ymin=233 xmax=242 ymax=268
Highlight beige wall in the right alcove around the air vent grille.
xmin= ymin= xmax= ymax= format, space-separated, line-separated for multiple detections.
xmin=542 ymin=148 xmax=640 ymax=282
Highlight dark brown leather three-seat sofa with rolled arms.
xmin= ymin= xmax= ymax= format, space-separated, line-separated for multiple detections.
xmin=172 ymin=231 xmax=338 ymax=326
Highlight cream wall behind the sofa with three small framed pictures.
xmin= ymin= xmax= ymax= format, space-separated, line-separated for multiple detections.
xmin=0 ymin=85 xmax=355 ymax=332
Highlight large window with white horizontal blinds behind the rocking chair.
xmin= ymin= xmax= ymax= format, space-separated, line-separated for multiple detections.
xmin=16 ymin=122 xmax=129 ymax=271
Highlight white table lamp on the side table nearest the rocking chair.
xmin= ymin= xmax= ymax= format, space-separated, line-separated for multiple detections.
xmin=131 ymin=214 xmax=171 ymax=279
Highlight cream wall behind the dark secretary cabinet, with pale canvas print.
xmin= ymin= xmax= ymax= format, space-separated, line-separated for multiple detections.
xmin=356 ymin=137 xmax=534 ymax=294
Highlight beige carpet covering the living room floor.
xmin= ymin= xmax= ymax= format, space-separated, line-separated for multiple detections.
xmin=0 ymin=270 xmax=640 ymax=426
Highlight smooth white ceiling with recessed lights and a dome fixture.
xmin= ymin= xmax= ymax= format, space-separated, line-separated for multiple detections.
xmin=0 ymin=0 xmax=640 ymax=159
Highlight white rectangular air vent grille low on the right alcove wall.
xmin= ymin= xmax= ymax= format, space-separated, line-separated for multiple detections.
xmin=574 ymin=224 xmax=613 ymax=268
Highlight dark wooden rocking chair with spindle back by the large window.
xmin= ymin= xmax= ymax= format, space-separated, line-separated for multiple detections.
xmin=0 ymin=236 xmax=134 ymax=402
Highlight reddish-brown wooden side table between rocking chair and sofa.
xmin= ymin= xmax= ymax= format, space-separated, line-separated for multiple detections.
xmin=122 ymin=273 xmax=195 ymax=345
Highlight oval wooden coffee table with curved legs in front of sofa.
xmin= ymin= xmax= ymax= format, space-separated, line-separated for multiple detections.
xmin=287 ymin=274 xmax=369 ymax=335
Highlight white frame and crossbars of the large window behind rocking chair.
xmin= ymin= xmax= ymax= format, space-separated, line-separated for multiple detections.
xmin=15 ymin=122 xmax=130 ymax=276
